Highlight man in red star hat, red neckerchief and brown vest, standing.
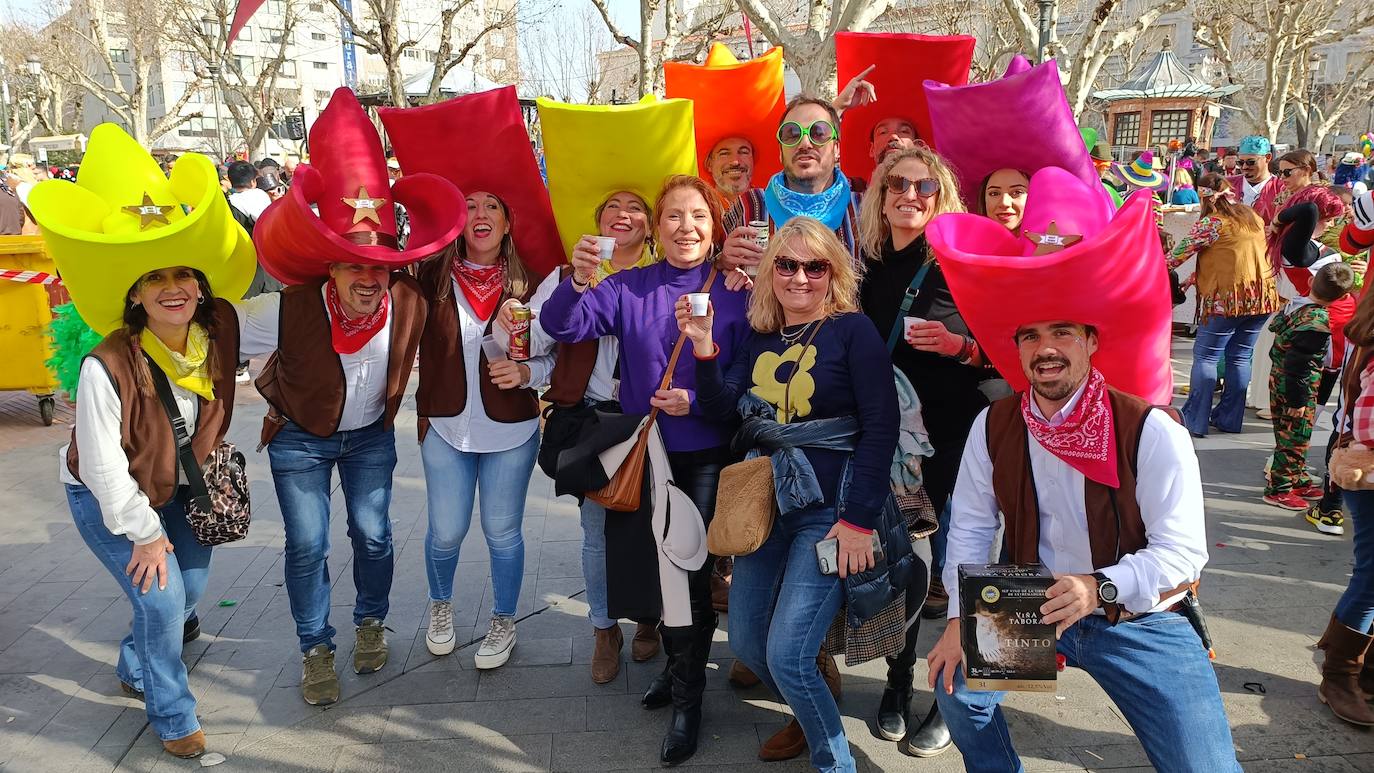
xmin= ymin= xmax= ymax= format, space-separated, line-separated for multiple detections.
xmin=240 ymin=88 xmax=467 ymax=706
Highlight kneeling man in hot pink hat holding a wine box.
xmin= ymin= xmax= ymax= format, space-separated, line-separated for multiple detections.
xmin=927 ymin=168 xmax=1241 ymax=773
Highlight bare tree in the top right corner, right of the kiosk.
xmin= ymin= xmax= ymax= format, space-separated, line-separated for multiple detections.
xmin=1194 ymin=0 xmax=1374 ymax=140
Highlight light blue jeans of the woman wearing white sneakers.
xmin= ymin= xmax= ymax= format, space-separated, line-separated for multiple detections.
xmin=420 ymin=430 xmax=539 ymax=616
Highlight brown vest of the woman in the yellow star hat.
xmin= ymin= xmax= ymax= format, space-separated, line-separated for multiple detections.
xmin=67 ymin=298 xmax=239 ymax=507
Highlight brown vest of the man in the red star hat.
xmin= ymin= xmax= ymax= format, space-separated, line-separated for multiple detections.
xmin=254 ymin=272 xmax=427 ymax=445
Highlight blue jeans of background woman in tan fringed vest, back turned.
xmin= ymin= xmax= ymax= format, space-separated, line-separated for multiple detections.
xmin=1183 ymin=314 xmax=1270 ymax=435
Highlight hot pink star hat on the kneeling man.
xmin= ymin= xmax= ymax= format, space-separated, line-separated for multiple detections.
xmin=926 ymin=166 xmax=1173 ymax=405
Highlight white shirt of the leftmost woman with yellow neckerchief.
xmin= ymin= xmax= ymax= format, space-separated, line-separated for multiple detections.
xmin=58 ymin=357 xmax=201 ymax=545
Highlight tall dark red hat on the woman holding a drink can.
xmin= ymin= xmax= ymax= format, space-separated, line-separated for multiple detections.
xmin=376 ymin=86 xmax=566 ymax=276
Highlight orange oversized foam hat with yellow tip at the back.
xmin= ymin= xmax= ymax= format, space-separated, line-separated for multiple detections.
xmin=664 ymin=43 xmax=787 ymax=188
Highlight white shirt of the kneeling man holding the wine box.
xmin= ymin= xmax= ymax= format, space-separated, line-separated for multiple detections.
xmin=944 ymin=384 xmax=1208 ymax=618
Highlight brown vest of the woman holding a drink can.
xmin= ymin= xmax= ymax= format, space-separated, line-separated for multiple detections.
xmin=415 ymin=254 xmax=539 ymax=441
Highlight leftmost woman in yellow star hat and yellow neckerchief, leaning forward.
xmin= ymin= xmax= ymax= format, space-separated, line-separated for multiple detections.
xmin=29 ymin=124 xmax=256 ymax=757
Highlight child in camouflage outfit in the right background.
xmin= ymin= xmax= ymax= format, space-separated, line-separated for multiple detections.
xmin=1264 ymin=262 xmax=1355 ymax=511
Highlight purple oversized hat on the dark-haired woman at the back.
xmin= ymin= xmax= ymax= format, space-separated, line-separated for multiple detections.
xmin=923 ymin=55 xmax=1107 ymax=212
